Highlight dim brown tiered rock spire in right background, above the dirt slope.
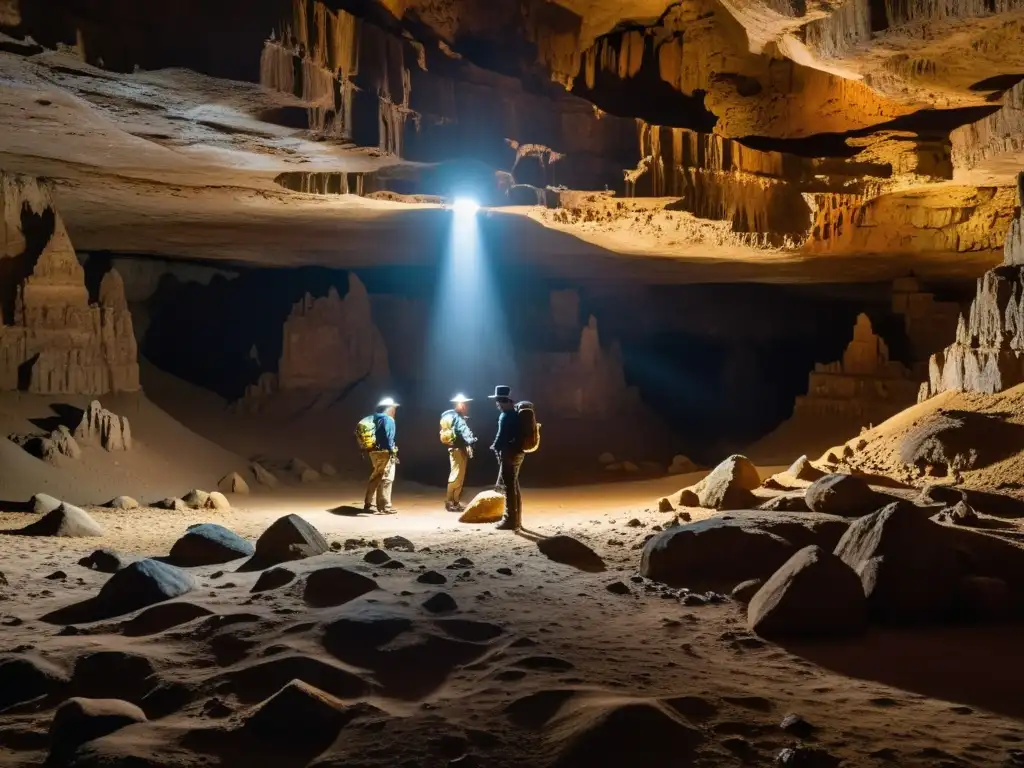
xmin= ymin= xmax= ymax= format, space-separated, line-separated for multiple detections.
xmin=794 ymin=314 xmax=918 ymax=424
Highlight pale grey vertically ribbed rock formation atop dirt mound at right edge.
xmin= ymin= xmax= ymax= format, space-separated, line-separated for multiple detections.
xmin=920 ymin=173 xmax=1024 ymax=400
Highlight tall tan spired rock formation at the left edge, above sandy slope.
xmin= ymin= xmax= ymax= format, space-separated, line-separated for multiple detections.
xmin=0 ymin=172 xmax=139 ymax=394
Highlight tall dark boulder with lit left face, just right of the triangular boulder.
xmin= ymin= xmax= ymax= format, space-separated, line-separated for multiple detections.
xmin=836 ymin=502 xmax=964 ymax=624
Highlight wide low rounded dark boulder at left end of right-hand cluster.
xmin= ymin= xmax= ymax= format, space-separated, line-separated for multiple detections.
xmin=640 ymin=517 xmax=796 ymax=589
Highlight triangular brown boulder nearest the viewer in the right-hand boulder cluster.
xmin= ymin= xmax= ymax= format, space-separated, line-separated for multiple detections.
xmin=746 ymin=545 xmax=867 ymax=637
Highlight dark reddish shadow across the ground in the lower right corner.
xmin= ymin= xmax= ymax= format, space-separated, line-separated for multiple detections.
xmin=782 ymin=625 xmax=1024 ymax=718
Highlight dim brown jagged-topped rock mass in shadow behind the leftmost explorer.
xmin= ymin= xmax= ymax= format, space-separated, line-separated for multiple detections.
xmin=245 ymin=273 xmax=388 ymax=407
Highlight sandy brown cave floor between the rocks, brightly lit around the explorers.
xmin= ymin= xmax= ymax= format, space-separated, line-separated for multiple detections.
xmin=6 ymin=477 xmax=1024 ymax=766
